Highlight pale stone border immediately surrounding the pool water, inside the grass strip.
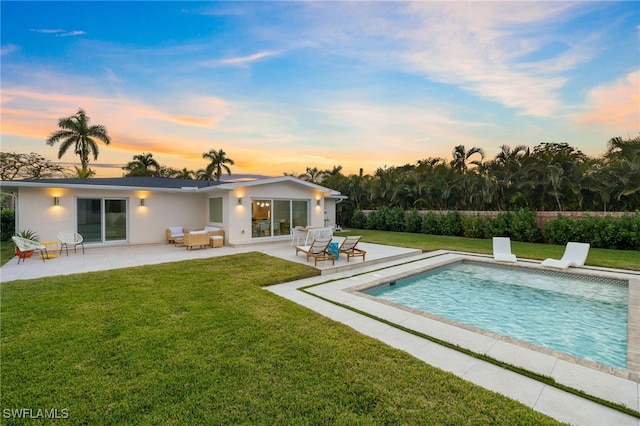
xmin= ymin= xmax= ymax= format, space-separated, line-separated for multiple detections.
xmin=305 ymin=251 xmax=640 ymax=411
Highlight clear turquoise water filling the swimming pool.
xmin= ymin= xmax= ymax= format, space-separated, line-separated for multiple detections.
xmin=365 ymin=261 xmax=628 ymax=369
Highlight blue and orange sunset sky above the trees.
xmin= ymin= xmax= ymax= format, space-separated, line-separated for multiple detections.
xmin=0 ymin=0 xmax=640 ymax=177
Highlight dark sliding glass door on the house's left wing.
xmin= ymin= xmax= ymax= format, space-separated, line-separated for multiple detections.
xmin=76 ymin=198 xmax=128 ymax=242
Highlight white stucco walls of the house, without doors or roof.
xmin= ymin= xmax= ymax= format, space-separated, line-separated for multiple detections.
xmin=10 ymin=180 xmax=342 ymax=245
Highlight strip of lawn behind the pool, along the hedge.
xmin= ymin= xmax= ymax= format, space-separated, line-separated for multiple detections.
xmin=340 ymin=229 xmax=640 ymax=271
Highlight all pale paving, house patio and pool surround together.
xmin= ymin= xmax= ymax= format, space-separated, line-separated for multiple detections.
xmin=0 ymin=242 xmax=640 ymax=426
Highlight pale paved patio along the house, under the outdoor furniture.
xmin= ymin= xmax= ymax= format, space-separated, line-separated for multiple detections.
xmin=0 ymin=237 xmax=421 ymax=282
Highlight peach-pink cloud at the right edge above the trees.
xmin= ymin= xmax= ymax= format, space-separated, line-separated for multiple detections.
xmin=575 ymin=70 xmax=640 ymax=134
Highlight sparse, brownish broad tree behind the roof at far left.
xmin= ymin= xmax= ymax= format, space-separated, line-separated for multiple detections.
xmin=0 ymin=152 xmax=68 ymax=180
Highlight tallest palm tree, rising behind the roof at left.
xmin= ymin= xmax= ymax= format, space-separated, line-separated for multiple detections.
xmin=47 ymin=108 xmax=111 ymax=177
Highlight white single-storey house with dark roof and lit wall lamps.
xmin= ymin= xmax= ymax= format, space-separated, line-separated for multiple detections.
xmin=2 ymin=176 xmax=346 ymax=246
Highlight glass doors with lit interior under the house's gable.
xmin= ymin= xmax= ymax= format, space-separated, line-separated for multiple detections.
xmin=251 ymin=199 xmax=309 ymax=238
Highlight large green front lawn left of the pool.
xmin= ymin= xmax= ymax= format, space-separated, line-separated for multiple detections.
xmin=0 ymin=253 xmax=557 ymax=425
